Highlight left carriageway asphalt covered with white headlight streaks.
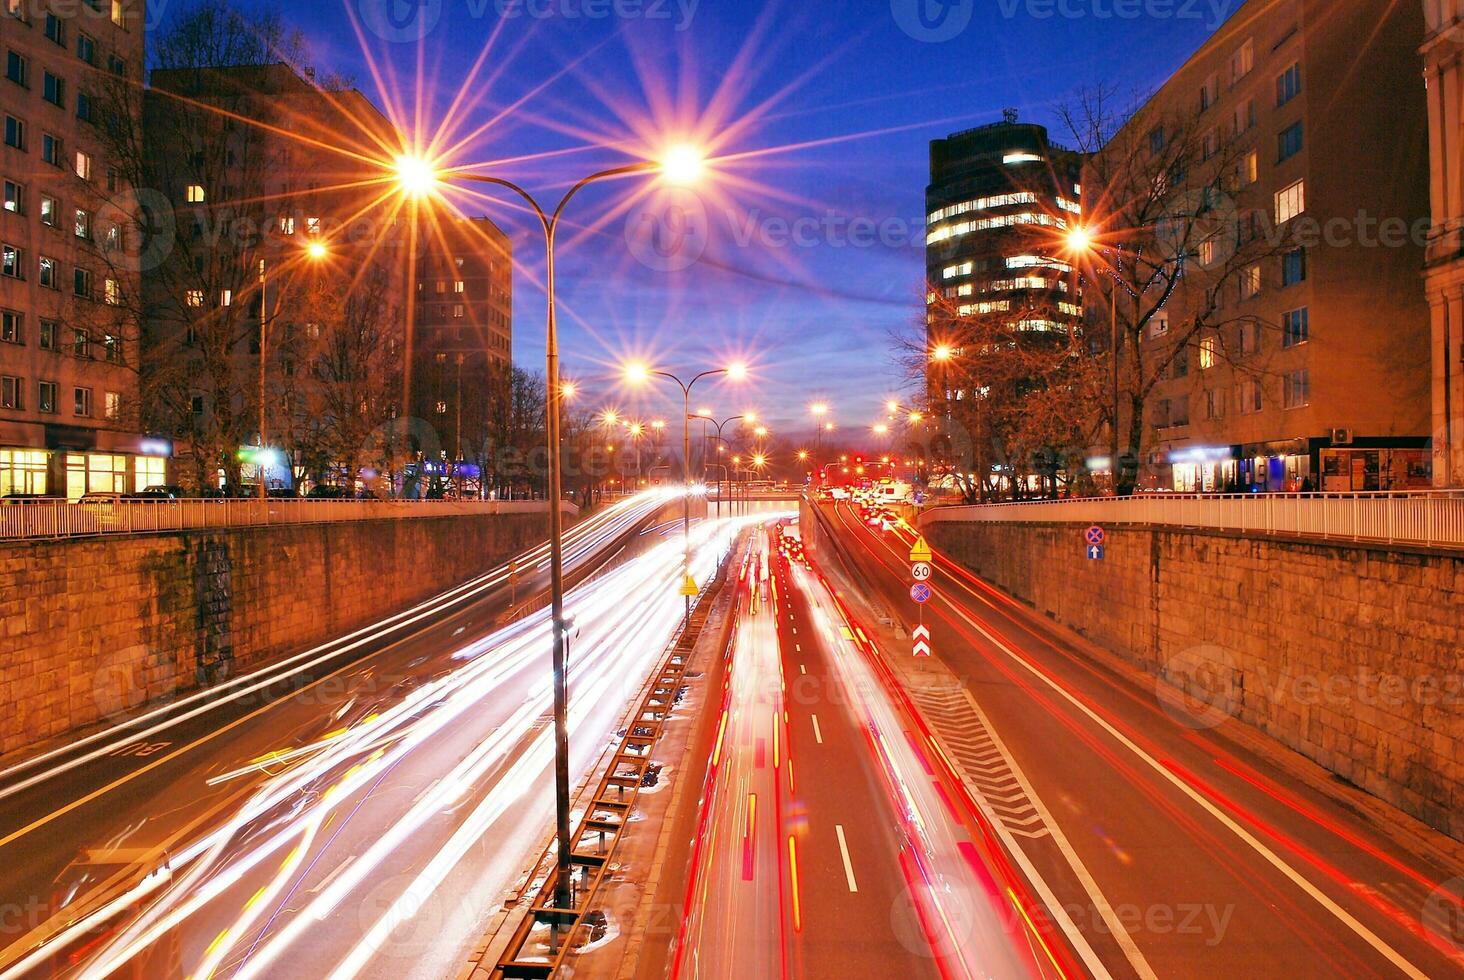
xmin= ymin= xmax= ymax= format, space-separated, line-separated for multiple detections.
xmin=0 ymin=498 xmax=722 ymax=979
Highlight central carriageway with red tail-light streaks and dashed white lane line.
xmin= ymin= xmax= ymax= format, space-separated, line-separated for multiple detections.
xmin=671 ymin=518 xmax=1064 ymax=979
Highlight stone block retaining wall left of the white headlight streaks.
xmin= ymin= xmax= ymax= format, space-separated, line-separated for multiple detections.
xmin=0 ymin=513 xmax=549 ymax=753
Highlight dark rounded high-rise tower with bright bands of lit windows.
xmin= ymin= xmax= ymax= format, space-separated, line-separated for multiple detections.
xmin=925 ymin=111 xmax=1082 ymax=363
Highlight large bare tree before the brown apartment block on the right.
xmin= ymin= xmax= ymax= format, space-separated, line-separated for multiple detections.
xmin=1058 ymin=88 xmax=1290 ymax=495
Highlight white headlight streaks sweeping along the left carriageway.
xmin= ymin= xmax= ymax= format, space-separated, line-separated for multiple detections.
xmin=0 ymin=500 xmax=763 ymax=980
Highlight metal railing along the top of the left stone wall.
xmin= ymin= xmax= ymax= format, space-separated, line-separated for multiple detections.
xmin=0 ymin=498 xmax=578 ymax=539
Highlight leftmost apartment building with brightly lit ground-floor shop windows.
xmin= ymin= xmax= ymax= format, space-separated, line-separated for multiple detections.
xmin=0 ymin=0 xmax=158 ymax=500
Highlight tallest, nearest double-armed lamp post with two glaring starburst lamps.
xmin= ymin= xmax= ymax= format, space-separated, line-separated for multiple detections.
xmin=395 ymin=146 xmax=703 ymax=919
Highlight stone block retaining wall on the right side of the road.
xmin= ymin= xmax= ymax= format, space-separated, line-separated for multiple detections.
xmin=925 ymin=520 xmax=1464 ymax=839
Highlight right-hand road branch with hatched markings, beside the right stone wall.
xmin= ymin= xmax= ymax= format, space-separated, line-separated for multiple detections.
xmin=821 ymin=504 xmax=1464 ymax=979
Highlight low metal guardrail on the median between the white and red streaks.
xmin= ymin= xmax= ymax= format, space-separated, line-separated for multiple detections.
xmin=490 ymin=564 xmax=726 ymax=980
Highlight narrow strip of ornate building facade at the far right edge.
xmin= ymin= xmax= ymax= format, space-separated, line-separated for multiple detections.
xmin=1422 ymin=0 xmax=1464 ymax=486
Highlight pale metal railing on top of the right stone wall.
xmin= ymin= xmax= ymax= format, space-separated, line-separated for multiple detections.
xmin=921 ymin=491 xmax=1464 ymax=548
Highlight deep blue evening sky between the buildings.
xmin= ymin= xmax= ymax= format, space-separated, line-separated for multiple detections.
xmin=151 ymin=0 xmax=1239 ymax=434
